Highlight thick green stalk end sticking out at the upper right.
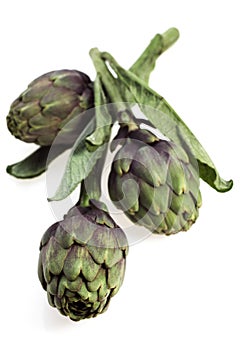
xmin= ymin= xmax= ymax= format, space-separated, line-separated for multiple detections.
xmin=129 ymin=28 xmax=179 ymax=83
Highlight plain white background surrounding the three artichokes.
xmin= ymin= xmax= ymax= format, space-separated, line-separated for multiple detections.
xmin=0 ymin=0 xmax=246 ymax=350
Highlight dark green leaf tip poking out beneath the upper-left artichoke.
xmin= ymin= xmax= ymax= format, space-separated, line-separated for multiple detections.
xmin=6 ymin=145 xmax=68 ymax=179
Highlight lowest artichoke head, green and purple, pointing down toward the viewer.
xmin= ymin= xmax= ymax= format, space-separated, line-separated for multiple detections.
xmin=38 ymin=207 xmax=128 ymax=321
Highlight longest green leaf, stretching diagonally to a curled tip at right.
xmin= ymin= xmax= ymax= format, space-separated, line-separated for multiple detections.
xmin=104 ymin=53 xmax=233 ymax=192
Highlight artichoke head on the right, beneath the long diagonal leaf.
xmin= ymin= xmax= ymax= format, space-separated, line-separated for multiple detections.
xmin=109 ymin=129 xmax=201 ymax=235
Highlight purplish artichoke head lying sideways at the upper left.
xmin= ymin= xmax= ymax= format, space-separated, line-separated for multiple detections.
xmin=7 ymin=69 xmax=94 ymax=146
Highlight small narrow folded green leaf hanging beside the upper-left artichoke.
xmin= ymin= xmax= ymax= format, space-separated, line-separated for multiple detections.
xmin=86 ymin=75 xmax=112 ymax=147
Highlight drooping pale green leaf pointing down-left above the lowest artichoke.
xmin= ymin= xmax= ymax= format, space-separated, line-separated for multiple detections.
xmin=49 ymin=119 xmax=106 ymax=201
